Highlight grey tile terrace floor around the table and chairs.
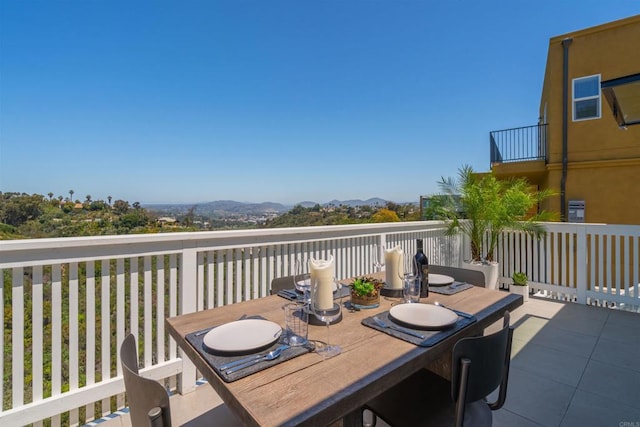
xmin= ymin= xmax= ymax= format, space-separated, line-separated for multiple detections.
xmin=96 ymin=298 xmax=640 ymax=427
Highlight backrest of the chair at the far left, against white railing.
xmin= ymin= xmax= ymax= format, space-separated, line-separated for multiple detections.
xmin=120 ymin=334 xmax=171 ymax=427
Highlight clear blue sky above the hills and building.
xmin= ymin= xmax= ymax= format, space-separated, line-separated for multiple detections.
xmin=0 ymin=0 xmax=640 ymax=204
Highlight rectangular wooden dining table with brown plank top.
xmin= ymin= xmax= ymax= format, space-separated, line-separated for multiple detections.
xmin=166 ymin=280 xmax=523 ymax=426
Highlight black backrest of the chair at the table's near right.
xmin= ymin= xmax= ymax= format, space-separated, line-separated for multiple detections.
xmin=451 ymin=311 xmax=513 ymax=409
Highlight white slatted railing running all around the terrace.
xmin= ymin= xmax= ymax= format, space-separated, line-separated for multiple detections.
xmin=0 ymin=221 xmax=640 ymax=426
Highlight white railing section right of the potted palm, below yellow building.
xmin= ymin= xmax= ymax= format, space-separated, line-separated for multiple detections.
xmin=498 ymin=223 xmax=640 ymax=311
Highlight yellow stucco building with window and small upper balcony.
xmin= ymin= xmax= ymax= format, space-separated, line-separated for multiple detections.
xmin=490 ymin=15 xmax=640 ymax=224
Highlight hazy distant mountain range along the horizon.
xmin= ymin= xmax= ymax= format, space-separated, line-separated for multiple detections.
xmin=144 ymin=197 xmax=387 ymax=217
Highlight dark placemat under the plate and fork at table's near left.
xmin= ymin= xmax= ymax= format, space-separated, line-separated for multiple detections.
xmin=185 ymin=322 xmax=314 ymax=382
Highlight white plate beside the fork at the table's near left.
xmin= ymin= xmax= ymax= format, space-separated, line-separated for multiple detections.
xmin=204 ymin=319 xmax=282 ymax=352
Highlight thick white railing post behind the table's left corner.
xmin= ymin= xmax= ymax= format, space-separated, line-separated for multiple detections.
xmin=178 ymin=247 xmax=198 ymax=394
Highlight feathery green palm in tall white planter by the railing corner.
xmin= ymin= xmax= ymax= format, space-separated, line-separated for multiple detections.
xmin=438 ymin=165 xmax=556 ymax=289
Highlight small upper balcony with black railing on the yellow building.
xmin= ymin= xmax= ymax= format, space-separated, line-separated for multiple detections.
xmin=489 ymin=123 xmax=547 ymax=177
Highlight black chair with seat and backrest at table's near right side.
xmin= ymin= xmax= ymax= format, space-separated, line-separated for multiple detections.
xmin=365 ymin=312 xmax=513 ymax=427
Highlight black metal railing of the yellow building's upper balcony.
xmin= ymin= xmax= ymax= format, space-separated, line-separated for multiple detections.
xmin=489 ymin=124 xmax=547 ymax=164
